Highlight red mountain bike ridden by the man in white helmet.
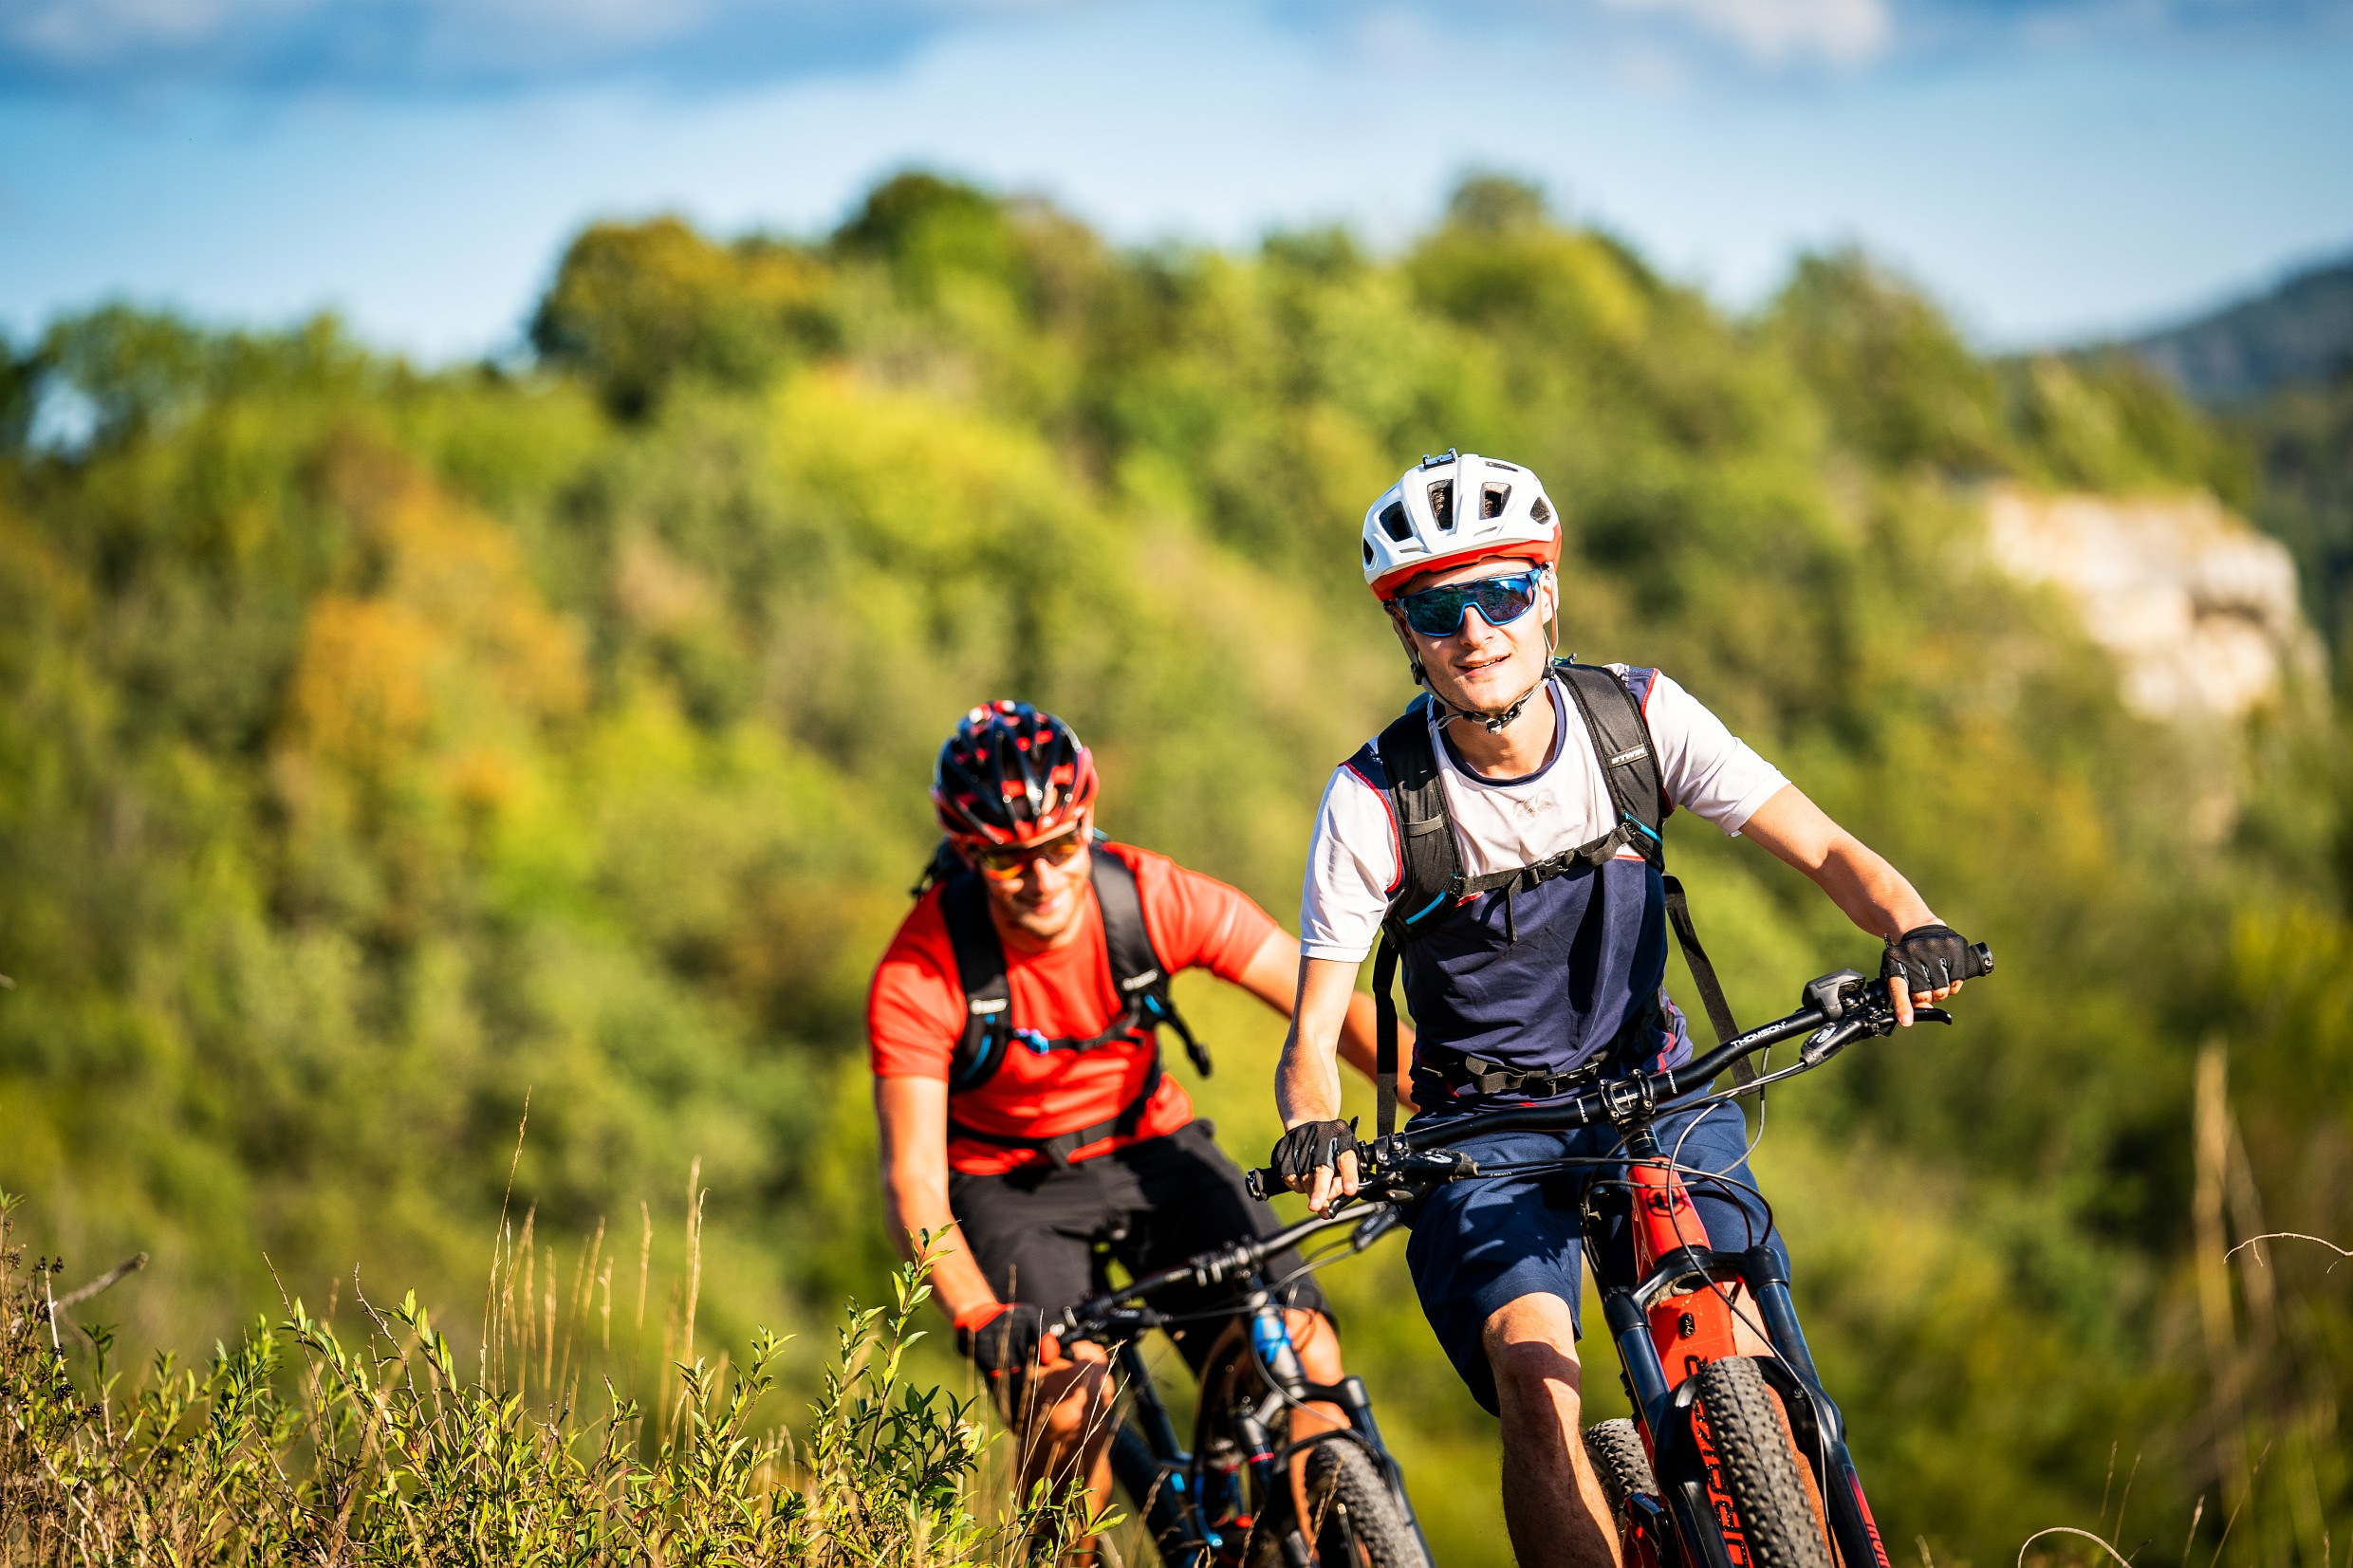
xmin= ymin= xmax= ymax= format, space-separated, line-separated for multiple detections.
xmin=1250 ymin=945 xmax=1993 ymax=1568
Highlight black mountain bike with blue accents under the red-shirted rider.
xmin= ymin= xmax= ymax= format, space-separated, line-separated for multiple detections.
xmin=1054 ymin=1204 xmax=1431 ymax=1568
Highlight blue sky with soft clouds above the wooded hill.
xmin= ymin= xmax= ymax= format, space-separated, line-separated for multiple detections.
xmin=0 ymin=0 xmax=2353 ymax=360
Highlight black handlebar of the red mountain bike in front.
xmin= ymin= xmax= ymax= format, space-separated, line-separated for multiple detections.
xmin=1245 ymin=943 xmax=1993 ymax=1201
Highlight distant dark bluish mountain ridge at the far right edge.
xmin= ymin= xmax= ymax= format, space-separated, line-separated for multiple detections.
xmin=2124 ymin=256 xmax=2353 ymax=407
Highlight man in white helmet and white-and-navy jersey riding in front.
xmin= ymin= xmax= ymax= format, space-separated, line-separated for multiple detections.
xmin=1270 ymin=452 xmax=1962 ymax=1568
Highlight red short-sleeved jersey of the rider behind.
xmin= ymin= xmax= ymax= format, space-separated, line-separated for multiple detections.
xmin=866 ymin=844 xmax=1275 ymax=1175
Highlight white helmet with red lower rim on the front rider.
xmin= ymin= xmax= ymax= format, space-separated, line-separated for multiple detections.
xmin=1364 ymin=449 xmax=1560 ymax=604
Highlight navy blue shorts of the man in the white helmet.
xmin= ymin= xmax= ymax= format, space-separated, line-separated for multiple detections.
xmin=1405 ymin=1105 xmax=1788 ymax=1415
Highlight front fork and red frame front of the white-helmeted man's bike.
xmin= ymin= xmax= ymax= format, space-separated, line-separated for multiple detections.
xmin=1595 ymin=1129 xmax=1889 ymax=1568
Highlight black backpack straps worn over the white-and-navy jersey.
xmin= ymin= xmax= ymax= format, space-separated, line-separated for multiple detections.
xmin=1348 ymin=658 xmax=1755 ymax=1137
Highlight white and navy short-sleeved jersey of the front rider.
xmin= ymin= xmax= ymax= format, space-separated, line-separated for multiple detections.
xmin=1299 ymin=670 xmax=1788 ymax=1096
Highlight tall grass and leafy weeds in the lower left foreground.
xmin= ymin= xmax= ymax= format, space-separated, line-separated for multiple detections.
xmin=0 ymin=1194 xmax=1108 ymax=1568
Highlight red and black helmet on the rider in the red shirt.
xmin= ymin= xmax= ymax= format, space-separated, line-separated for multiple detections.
xmin=932 ymin=703 xmax=1094 ymax=844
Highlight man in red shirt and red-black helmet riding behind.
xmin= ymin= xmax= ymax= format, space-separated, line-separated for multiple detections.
xmin=866 ymin=703 xmax=1402 ymax=1541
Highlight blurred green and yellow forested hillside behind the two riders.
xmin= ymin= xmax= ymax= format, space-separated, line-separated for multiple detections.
xmin=0 ymin=174 xmax=2353 ymax=1568
